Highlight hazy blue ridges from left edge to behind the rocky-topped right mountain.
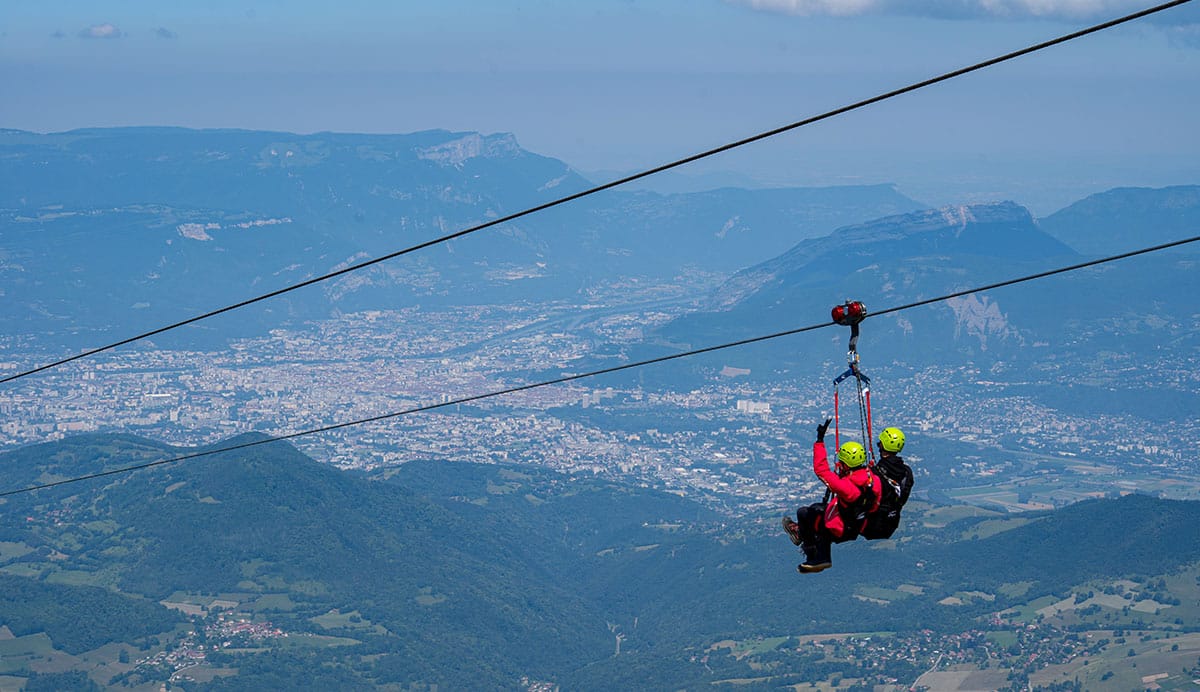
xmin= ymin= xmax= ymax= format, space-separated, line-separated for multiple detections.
xmin=0 ymin=128 xmax=922 ymax=341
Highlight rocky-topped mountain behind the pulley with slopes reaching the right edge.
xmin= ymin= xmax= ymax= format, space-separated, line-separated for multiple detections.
xmin=654 ymin=196 xmax=1200 ymax=367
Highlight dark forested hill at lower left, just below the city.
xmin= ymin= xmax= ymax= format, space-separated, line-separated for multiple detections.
xmin=0 ymin=435 xmax=606 ymax=675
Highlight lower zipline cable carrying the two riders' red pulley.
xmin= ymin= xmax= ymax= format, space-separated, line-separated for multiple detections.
xmin=0 ymin=235 xmax=1200 ymax=498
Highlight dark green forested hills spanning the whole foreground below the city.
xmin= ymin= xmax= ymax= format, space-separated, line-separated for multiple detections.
xmin=0 ymin=435 xmax=1200 ymax=688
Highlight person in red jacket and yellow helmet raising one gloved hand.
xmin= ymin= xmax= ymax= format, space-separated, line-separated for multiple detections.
xmin=784 ymin=419 xmax=880 ymax=573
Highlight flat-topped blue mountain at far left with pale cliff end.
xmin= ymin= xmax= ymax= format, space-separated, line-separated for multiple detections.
xmin=0 ymin=128 xmax=586 ymax=345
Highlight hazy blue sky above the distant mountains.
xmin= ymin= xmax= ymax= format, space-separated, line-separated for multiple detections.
xmin=0 ymin=0 xmax=1200 ymax=213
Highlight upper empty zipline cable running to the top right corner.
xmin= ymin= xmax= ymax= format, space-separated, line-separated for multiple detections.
xmin=0 ymin=0 xmax=1192 ymax=384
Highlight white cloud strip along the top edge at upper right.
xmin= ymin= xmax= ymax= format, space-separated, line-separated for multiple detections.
xmin=726 ymin=0 xmax=1195 ymax=24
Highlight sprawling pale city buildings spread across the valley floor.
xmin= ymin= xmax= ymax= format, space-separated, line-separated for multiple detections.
xmin=0 ymin=287 xmax=1200 ymax=507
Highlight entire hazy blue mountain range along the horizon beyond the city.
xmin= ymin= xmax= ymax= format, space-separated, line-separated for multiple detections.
xmin=0 ymin=128 xmax=1200 ymax=374
